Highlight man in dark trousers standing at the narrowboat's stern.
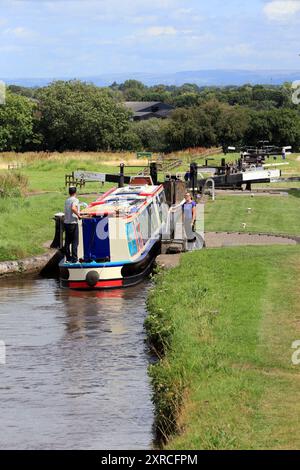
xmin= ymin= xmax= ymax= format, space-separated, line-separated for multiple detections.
xmin=64 ymin=187 xmax=81 ymax=263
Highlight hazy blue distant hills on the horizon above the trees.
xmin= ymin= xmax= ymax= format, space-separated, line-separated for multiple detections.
xmin=2 ymin=70 xmax=300 ymax=87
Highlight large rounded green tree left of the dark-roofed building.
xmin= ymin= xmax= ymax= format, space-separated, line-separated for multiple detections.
xmin=38 ymin=81 xmax=130 ymax=151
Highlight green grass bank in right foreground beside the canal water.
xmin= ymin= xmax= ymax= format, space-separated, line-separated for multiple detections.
xmin=146 ymin=246 xmax=300 ymax=449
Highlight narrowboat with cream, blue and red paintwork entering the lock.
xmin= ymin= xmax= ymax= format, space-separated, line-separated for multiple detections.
xmin=59 ymin=177 xmax=168 ymax=290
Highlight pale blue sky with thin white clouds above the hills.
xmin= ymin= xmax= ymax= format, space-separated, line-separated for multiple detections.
xmin=0 ymin=0 xmax=300 ymax=78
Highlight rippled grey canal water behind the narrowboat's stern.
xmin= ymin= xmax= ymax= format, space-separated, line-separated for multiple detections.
xmin=0 ymin=279 xmax=153 ymax=449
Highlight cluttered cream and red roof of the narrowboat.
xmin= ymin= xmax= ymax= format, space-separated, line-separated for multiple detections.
xmin=81 ymin=185 xmax=163 ymax=217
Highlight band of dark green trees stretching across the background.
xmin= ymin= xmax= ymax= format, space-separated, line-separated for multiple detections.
xmin=0 ymin=80 xmax=300 ymax=152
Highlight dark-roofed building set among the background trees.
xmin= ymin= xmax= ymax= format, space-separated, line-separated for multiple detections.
xmin=125 ymin=101 xmax=174 ymax=121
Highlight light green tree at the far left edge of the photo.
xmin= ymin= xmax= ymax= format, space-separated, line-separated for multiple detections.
xmin=0 ymin=90 xmax=36 ymax=152
